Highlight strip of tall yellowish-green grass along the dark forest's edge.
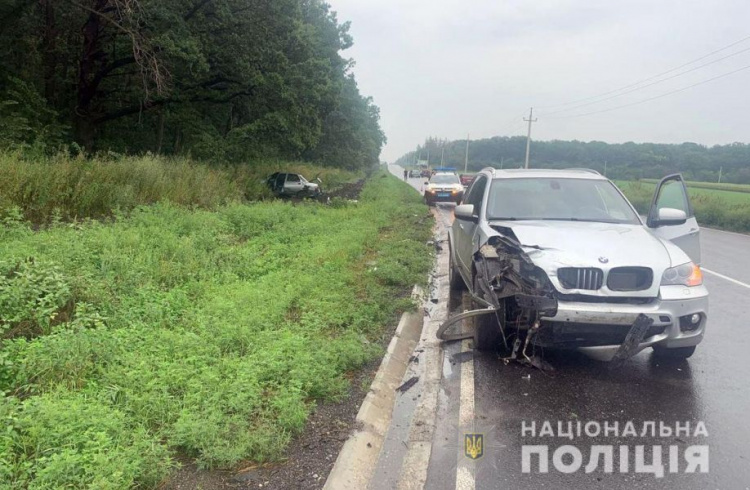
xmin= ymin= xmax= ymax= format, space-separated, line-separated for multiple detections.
xmin=0 ymin=153 xmax=360 ymax=224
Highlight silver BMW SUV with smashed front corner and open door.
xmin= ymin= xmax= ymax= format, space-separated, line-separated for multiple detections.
xmin=446 ymin=169 xmax=708 ymax=365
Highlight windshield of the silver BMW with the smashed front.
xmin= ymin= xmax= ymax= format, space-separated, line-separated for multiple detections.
xmin=487 ymin=178 xmax=640 ymax=224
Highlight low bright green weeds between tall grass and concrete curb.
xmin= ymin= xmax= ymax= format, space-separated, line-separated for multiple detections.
xmin=0 ymin=172 xmax=432 ymax=489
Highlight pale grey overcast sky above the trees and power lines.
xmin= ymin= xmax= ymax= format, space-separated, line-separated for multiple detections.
xmin=329 ymin=0 xmax=750 ymax=161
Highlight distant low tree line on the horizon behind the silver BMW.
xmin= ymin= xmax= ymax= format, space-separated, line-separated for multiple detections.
xmin=399 ymin=136 xmax=750 ymax=184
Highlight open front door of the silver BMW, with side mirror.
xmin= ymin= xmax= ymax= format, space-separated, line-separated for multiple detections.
xmin=646 ymin=174 xmax=701 ymax=264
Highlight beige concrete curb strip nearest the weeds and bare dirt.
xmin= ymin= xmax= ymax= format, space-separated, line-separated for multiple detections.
xmin=323 ymin=286 xmax=424 ymax=490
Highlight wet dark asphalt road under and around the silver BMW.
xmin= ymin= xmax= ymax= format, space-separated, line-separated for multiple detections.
xmin=391 ymin=166 xmax=750 ymax=489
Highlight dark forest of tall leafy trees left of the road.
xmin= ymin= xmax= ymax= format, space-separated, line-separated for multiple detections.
xmin=0 ymin=0 xmax=385 ymax=169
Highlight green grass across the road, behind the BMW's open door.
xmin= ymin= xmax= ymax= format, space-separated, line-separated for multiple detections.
xmin=616 ymin=181 xmax=750 ymax=232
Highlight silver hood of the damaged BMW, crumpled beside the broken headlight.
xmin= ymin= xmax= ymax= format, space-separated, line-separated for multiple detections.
xmin=490 ymin=221 xmax=671 ymax=297
